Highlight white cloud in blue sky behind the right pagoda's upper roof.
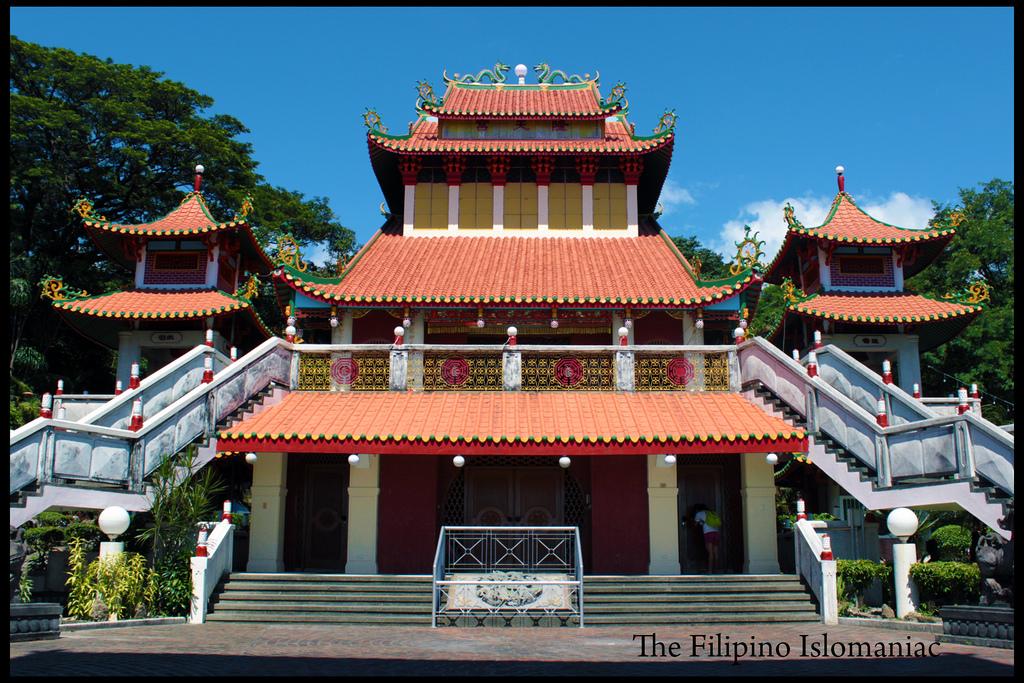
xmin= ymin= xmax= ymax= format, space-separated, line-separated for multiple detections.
xmin=711 ymin=193 xmax=934 ymax=263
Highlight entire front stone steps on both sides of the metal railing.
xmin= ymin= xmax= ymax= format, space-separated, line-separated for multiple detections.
xmin=207 ymin=572 xmax=821 ymax=627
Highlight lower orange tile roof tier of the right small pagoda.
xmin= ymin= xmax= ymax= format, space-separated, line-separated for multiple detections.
xmin=786 ymin=292 xmax=983 ymax=324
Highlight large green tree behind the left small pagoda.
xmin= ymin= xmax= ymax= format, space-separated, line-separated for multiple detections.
xmin=8 ymin=36 xmax=355 ymax=403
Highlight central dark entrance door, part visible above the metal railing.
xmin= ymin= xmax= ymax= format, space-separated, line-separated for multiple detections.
xmin=466 ymin=467 xmax=564 ymax=526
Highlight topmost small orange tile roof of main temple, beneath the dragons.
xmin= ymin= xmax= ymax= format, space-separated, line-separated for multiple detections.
xmin=423 ymin=82 xmax=622 ymax=119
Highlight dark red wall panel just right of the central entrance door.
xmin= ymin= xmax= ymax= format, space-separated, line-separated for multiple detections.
xmin=585 ymin=456 xmax=650 ymax=573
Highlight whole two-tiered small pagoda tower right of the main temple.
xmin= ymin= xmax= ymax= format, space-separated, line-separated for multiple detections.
xmin=765 ymin=166 xmax=988 ymax=393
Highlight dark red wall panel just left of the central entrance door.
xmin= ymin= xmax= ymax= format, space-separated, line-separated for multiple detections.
xmin=377 ymin=456 xmax=440 ymax=573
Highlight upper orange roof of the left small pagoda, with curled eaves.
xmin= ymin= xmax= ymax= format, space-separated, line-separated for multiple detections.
xmin=76 ymin=191 xmax=273 ymax=273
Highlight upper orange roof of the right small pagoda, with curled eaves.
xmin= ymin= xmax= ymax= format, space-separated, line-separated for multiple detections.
xmin=765 ymin=191 xmax=956 ymax=284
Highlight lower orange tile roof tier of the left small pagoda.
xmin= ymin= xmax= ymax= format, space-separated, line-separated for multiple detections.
xmin=53 ymin=290 xmax=258 ymax=318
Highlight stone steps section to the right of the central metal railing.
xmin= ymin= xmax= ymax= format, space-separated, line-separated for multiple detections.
xmin=584 ymin=574 xmax=821 ymax=627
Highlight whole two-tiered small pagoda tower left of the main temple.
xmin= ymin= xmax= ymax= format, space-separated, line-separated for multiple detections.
xmin=43 ymin=166 xmax=273 ymax=388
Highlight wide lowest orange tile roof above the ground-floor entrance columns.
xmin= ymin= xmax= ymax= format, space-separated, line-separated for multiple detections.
xmin=217 ymin=391 xmax=806 ymax=453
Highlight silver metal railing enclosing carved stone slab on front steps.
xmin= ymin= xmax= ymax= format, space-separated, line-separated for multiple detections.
xmin=430 ymin=526 xmax=584 ymax=628
